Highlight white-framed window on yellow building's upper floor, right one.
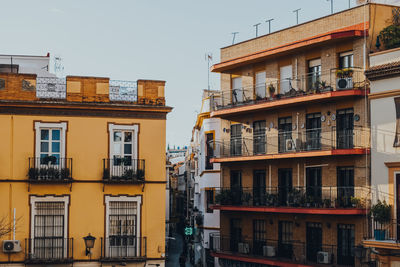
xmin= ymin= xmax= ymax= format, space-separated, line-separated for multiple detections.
xmin=109 ymin=124 xmax=139 ymax=177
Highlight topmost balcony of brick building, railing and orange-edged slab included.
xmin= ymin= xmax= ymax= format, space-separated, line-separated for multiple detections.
xmin=211 ymin=68 xmax=367 ymax=117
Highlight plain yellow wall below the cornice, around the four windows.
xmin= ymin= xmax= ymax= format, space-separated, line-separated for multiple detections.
xmin=0 ymin=115 xmax=165 ymax=261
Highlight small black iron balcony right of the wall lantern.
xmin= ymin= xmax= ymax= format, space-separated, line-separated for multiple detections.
xmin=101 ymin=236 xmax=147 ymax=261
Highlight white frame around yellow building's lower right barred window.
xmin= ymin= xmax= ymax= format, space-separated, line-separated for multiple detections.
xmin=104 ymin=195 xmax=142 ymax=256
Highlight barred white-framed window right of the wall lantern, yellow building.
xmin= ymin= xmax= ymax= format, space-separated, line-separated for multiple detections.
xmin=105 ymin=196 xmax=142 ymax=258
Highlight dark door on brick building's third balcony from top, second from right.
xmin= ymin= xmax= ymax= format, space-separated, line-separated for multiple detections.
xmin=306 ymin=167 xmax=322 ymax=205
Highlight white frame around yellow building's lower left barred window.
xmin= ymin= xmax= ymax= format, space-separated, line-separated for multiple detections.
xmin=29 ymin=196 xmax=69 ymax=256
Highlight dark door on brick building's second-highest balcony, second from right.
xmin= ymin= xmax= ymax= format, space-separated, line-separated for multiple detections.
xmin=305 ymin=113 xmax=321 ymax=150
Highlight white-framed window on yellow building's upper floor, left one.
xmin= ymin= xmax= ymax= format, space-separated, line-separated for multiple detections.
xmin=35 ymin=122 xmax=67 ymax=166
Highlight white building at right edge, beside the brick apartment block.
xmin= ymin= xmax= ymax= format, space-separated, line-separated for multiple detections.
xmin=364 ymin=48 xmax=400 ymax=266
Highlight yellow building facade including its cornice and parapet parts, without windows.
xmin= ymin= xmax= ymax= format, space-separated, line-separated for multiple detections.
xmin=0 ymin=74 xmax=171 ymax=266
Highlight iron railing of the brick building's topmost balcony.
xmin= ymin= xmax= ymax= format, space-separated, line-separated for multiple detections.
xmin=211 ymin=67 xmax=367 ymax=110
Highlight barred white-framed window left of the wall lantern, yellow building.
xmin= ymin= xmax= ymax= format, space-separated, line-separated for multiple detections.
xmin=29 ymin=196 xmax=69 ymax=260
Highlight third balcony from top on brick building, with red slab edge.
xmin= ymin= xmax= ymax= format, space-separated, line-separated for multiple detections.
xmin=212 ymin=186 xmax=369 ymax=215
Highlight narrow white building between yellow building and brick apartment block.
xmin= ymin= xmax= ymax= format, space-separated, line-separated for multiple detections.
xmin=191 ymin=90 xmax=222 ymax=267
